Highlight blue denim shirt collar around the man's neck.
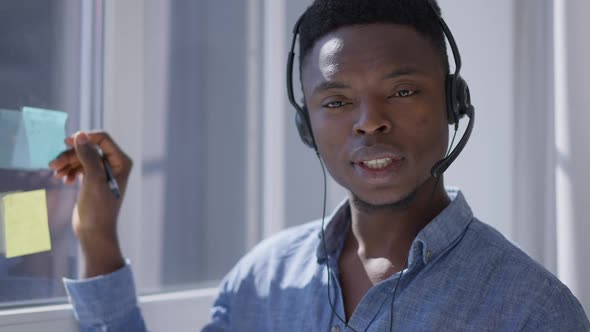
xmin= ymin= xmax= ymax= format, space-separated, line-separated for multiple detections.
xmin=316 ymin=188 xmax=473 ymax=266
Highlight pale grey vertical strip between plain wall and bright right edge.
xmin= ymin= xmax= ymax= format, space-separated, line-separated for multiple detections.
xmin=513 ymin=0 xmax=557 ymax=274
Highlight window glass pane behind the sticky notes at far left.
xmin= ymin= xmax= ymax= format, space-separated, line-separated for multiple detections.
xmin=0 ymin=0 xmax=99 ymax=307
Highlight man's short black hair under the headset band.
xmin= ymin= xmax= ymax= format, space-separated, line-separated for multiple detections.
xmin=299 ymin=0 xmax=449 ymax=73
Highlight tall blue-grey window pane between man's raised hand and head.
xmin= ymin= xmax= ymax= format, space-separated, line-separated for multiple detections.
xmin=136 ymin=0 xmax=255 ymax=293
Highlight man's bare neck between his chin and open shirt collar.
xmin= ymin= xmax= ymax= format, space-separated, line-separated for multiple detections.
xmin=346 ymin=177 xmax=450 ymax=264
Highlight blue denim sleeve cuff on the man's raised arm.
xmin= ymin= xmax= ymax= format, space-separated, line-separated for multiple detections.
xmin=63 ymin=262 xmax=147 ymax=332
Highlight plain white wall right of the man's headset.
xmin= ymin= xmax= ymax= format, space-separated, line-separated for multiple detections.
xmin=439 ymin=0 xmax=514 ymax=239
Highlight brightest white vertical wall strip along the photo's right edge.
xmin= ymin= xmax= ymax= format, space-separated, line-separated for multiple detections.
xmin=553 ymin=0 xmax=590 ymax=314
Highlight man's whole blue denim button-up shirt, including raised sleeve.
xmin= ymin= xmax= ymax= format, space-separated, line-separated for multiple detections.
xmin=66 ymin=190 xmax=590 ymax=332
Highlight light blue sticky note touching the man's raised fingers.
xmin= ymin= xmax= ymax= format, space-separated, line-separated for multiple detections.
xmin=22 ymin=107 xmax=68 ymax=169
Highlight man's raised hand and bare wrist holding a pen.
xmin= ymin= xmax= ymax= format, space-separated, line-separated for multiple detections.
xmin=49 ymin=132 xmax=132 ymax=278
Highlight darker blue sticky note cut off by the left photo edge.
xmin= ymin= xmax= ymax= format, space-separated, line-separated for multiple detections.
xmin=0 ymin=109 xmax=30 ymax=168
